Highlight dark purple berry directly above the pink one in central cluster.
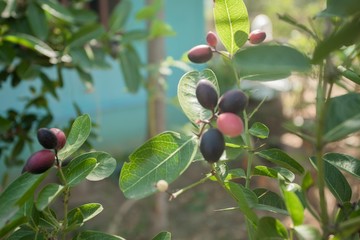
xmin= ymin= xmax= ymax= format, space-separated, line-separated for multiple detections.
xmin=219 ymin=89 xmax=248 ymax=114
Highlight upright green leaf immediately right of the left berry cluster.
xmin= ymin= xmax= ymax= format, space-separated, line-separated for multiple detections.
xmin=58 ymin=114 xmax=91 ymax=160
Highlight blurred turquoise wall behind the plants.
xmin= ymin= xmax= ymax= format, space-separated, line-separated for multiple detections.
xmin=0 ymin=0 xmax=205 ymax=157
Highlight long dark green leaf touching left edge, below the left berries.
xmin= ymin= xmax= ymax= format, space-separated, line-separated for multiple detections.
xmin=0 ymin=173 xmax=47 ymax=229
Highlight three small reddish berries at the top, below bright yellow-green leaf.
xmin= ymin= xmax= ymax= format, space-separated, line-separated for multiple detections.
xmin=188 ymin=30 xmax=266 ymax=63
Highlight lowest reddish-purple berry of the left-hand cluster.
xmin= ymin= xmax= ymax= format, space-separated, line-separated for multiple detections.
xmin=22 ymin=149 xmax=55 ymax=174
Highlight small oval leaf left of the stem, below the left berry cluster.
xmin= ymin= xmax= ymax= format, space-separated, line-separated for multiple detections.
xmin=35 ymin=183 xmax=64 ymax=211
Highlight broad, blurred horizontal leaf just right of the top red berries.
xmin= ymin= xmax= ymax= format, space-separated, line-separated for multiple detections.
xmin=233 ymin=45 xmax=311 ymax=81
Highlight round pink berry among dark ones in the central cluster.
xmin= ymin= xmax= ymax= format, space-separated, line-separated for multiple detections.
xmin=216 ymin=112 xmax=244 ymax=137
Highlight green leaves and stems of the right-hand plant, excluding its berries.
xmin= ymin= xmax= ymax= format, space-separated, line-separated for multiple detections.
xmin=119 ymin=0 xmax=360 ymax=239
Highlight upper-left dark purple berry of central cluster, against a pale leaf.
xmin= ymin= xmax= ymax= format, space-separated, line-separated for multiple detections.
xmin=196 ymin=79 xmax=219 ymax=110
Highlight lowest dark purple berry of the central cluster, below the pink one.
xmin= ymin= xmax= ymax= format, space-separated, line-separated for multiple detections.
xmin=200 ymin=128 xmax=225 ymax=163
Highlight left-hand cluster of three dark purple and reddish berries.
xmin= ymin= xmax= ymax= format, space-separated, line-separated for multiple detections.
xmin=22 ymin=128 xmax=66 ymax=174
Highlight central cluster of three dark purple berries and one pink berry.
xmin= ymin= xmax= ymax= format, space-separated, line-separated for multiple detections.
xmin=196 ymin=79 xmax=248 ymax=163
